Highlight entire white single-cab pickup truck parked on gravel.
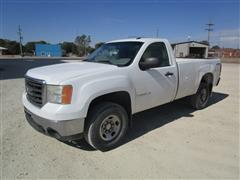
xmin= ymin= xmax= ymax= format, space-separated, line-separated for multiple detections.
xmin=22 ymin=38 xmax=221 ymax=151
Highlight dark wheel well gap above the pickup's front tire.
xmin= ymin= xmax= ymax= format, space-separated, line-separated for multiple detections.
xmin=88 ymin=91 xmax=132 ymax=120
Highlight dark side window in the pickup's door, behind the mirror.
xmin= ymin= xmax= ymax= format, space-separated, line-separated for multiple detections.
xmin=140 ymin=42 xmax=170 ymax=67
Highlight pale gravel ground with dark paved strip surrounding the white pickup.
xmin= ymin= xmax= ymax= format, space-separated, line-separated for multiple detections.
xmin=0 ymin=60 xmax=240 ymax=179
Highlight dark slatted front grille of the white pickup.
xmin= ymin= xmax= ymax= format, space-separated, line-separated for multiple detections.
xmin=25 ymin=77 xmax=44 ymax=107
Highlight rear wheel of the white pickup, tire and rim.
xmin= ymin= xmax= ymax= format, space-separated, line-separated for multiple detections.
xmin=190 ymin=83 xmax=211 ymax=110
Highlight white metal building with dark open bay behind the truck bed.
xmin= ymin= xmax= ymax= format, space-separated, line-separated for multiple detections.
xmin=172 ymin=41 xmax=208 ymax=58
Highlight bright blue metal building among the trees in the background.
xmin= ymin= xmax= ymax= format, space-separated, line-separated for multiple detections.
xmin=35 ymin=44 xmax=62 ymax=57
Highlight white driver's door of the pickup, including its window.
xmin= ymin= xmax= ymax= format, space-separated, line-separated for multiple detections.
xmin=135 ymin=42 xmax=178 ymax=112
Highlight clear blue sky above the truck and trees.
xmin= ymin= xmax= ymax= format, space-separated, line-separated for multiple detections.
xmin=0 ymin=0 xmax=240 ymax=48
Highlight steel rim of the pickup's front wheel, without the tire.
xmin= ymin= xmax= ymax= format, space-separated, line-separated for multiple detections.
xmin=100 ymin=115 xmax=121 ymax=141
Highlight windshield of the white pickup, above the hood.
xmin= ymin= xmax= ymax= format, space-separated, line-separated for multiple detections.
xmin=85 ymin=42 xmax=143 ymax=66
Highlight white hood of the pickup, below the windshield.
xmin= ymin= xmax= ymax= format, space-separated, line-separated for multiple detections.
xmin=26 ymin=62 xmax=118 ymax=84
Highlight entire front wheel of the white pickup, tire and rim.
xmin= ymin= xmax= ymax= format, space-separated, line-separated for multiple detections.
xmin=84 ymin=102 xmax=129 ymax=151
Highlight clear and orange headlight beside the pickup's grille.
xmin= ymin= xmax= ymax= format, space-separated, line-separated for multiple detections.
xmin=47 ymin=85 xmax=72 ymax=104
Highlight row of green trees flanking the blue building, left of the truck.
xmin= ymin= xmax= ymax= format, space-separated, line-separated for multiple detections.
xmin=0 ymin=34 xmax=103 ymax=56
